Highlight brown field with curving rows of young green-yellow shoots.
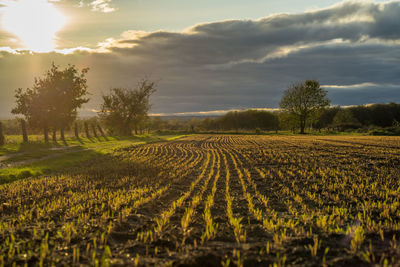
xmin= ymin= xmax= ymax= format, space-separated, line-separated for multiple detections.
xmin=0 ymin=135 xmax=400 ymax=266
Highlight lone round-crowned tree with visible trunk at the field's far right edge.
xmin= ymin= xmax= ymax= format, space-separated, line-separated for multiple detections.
xmin=280 ymin=80 xmax=330 ymax=134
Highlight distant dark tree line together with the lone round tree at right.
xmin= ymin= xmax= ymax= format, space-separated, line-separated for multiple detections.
xmin=150 ymin=80 xmax=400 ymax=134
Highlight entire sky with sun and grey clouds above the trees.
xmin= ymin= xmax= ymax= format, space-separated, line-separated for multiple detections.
xmin=0 ymin=0 xmax=400 ymax=117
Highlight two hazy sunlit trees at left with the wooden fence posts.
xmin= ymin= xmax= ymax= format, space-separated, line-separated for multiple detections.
xmin=4 ymin=63 xmax=155 ymax=142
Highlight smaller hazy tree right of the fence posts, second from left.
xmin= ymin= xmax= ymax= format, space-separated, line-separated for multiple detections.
xmin=99 ymin=79 xmax=155 ymax=135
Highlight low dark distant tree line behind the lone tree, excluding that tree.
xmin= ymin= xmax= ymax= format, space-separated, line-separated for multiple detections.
xmin=148 ymin=103 xmax=400 ymax=134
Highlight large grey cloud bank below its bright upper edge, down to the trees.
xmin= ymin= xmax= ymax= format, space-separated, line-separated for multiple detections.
xmin=0 ymin=1 xmax=400 ymax=116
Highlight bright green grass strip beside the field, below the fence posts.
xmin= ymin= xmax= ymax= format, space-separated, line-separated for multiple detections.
xmin=0 ymin=135 xmax=191 ymax=184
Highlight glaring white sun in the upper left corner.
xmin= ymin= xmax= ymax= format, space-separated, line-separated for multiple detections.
xmin=2 ymin=0 xmax=66 ymax=52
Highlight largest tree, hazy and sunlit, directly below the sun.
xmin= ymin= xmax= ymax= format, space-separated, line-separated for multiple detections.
xmin=11 ymin=63 xmax=89 ymax=141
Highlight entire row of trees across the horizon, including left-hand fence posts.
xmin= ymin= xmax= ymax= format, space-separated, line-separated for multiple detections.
xmin=0 ymin=63 xmax=400 ymax=145
